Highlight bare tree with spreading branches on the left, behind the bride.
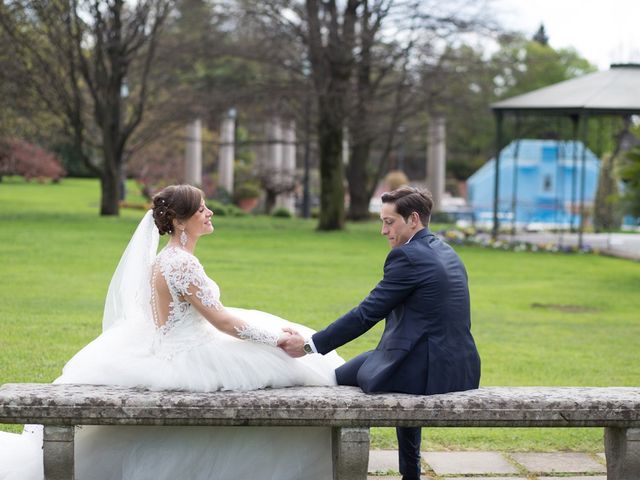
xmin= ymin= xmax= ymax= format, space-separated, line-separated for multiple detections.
xmin=0 ymin=0 xmax=172 ymax=215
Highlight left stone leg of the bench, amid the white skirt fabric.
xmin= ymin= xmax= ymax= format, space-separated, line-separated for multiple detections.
xmin=42 ymin=425 xmax=74 ymax=480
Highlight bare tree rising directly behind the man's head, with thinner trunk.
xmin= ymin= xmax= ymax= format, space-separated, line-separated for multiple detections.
xmin=347 ymin=0 xmax=496 ymax=220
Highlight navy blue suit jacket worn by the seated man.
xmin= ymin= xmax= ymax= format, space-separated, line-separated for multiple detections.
xmin=312 ymin=228 xmax=480 ymax=395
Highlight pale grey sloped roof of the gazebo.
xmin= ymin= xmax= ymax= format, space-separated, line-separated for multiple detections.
xmin=491 ymin=64 xmax=640 ymax=115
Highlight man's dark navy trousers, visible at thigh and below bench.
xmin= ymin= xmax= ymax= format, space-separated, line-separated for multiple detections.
xmin=336 ymin=351 xmax=421 ymax=480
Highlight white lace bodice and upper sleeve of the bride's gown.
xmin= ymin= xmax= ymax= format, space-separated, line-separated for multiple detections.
xmin=151 ymin=246 xmax=222 ymax=333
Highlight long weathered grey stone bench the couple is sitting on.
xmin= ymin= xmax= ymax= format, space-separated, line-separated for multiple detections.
xmin=0 ymin=384 xmax=640 ymax=480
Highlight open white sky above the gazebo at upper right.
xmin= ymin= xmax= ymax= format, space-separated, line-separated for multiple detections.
xmin=492 ymin=0 xmax=640 ymax=70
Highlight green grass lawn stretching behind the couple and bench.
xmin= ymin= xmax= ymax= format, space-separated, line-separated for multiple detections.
xmin=0 ymin=178 xmax=640 ymax=451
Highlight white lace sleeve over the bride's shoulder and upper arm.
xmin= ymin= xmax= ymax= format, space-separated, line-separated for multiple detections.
xmin=161 ymin=253 xmax=222 ymax=310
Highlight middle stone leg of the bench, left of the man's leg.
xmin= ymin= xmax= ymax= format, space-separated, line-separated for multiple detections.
xmin=331 ymin=428 xmax=369 ymax=480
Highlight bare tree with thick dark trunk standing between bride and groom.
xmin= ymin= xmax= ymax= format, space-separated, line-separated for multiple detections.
xmin=239 ymin=0 xmax=362 ymax=230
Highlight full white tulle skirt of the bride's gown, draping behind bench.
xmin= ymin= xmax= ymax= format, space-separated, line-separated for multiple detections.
xmin=0 ymin=309 xmax=343 ymax=480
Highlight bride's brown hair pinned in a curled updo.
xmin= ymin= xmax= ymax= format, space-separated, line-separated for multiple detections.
xmin=151 ymin=185 xmax=204 ymax=235
